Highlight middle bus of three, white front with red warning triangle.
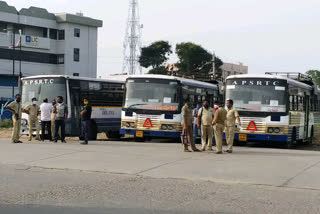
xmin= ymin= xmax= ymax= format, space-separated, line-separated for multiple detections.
xmin=120 ymin=75 xmax=220 ymax=141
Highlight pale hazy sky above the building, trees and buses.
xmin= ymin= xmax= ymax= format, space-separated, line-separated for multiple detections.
xmin=6 ymin=0 xmax=320 ymax=77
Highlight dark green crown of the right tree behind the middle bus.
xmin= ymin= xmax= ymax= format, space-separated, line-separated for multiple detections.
xmin=176 ymin=42 xmax=212 ymax=74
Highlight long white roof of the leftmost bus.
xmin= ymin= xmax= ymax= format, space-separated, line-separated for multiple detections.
xmin=22 ymin=75 xmax=128 ymax=83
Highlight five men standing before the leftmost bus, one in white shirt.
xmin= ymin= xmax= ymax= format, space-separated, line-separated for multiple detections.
xmin=7 ymin=94 xmax=92 ymax=144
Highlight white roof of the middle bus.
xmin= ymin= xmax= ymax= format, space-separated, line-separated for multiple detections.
xmin=128 ymin=74 xmax=218 ymax=90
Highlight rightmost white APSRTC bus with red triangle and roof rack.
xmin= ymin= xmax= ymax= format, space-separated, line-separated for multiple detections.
xmin=225 ymin=73 xmax=320 ymax=148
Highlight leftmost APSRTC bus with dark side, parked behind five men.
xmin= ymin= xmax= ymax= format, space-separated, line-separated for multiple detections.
xmin=21 ymin=75 xmax=125 ymax=140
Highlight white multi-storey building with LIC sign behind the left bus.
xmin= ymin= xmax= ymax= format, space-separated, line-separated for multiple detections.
xmin=0 ymin=1 xmax=102 ymax=99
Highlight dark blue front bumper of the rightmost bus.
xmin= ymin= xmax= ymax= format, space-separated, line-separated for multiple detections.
xmin=226 ymin=133 xmax=288 ymax=142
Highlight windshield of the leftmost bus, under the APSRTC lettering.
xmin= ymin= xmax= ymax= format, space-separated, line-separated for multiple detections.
xmin=22 ymin=78 xmax=67 ymax=106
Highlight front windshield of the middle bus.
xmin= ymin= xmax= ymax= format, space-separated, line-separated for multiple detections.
xmin=124 ymin=79 xmax=179 ymax=111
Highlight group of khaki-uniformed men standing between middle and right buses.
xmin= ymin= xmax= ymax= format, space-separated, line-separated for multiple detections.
xmin=182 ymin=98 xmax=241 ymax=154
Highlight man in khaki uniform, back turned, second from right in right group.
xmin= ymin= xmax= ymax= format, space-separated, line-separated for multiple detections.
xmin=212 ymin=104 xmax=227 ymax=154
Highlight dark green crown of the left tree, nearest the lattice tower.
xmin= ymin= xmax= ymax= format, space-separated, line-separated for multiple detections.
xmin=139 ymin=41 xmax=172 ymax=69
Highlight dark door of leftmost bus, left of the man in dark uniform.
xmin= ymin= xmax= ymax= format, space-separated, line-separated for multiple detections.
xmin=70 ymin=81 xmax=82 ymax=136
